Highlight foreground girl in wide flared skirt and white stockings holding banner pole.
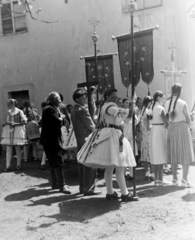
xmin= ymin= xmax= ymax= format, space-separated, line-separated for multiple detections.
xmin=77 ymin=89 xmax=136 ymax=201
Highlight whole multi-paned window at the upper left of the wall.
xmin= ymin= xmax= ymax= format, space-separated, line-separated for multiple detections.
xmin=1 ymin=1 xmax=27 ymax=36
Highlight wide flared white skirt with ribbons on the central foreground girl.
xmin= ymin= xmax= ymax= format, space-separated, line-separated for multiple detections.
xmin=77 ymin=128 xmax=136 ymax=168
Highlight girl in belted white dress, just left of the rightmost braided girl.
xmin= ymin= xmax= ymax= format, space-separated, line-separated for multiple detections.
xmin=150 ymin=91 xmax=168 ymax=186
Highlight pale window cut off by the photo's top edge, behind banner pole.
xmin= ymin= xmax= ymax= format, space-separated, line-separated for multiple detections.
xmin=122 ymin=0 xmax=163 ymax=13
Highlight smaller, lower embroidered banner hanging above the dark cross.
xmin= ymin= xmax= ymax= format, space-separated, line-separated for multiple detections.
xmin=85 ymin=54 xmax=114 ymax=94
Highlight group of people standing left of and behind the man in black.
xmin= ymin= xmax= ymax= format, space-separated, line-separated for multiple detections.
xmin=1 ymin=94 xmax=72 ymax=172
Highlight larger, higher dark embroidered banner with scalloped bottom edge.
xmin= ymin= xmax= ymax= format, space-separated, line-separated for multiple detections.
xmin=117 ymin=29 xmax=154 ymax=88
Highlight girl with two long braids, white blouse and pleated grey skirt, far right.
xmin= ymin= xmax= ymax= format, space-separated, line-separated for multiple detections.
xmin=165 ymin=83 xmax=194 ymax=187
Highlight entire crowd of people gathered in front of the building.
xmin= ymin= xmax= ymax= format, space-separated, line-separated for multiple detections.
xmin=1 ymin=83 xmax=195 ymax=202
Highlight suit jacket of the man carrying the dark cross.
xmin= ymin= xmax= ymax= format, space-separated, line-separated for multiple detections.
xmin=71 ymin=104 xmax=95 ymax=151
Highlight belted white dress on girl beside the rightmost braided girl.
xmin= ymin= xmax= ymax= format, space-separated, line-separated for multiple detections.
xmin=150 ymin=102 xmax=167 ymax=165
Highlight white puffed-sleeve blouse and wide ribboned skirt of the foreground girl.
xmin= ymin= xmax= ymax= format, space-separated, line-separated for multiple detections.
xmin=77 ymin=103 xmax=136 ymax=168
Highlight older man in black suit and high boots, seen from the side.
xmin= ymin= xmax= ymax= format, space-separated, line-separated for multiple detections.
xmin=41 ymin=92 xmax=71 ymax=194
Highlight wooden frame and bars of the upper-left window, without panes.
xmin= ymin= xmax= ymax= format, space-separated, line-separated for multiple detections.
xmin=0 ymin=0 xmax=28 ymax=37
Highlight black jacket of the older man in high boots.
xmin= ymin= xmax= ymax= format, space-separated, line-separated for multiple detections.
xmin=41 ymin=104 xmax=62 ymax=147
